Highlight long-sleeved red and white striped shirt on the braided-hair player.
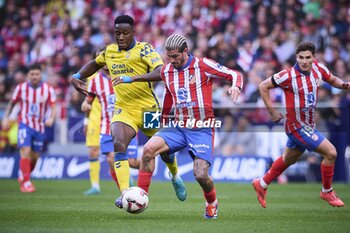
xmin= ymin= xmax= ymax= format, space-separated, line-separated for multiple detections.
xmin=161 ymin=56 xmax=243 ymax=120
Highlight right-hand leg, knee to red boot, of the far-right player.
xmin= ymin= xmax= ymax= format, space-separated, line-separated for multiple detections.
xmin=315 ymin=139 xmax=344 ymax=207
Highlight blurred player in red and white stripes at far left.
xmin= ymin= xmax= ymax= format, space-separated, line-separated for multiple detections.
xmin=2 ymin=64 xmax=56 ymax=192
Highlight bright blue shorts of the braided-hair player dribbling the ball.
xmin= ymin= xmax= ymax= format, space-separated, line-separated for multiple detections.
xmin=155 ymin=127 xmax=214 ymax=165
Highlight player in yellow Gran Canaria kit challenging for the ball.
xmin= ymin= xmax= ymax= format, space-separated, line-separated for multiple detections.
xmin=71 ymin=15 xmax=186 ymax=208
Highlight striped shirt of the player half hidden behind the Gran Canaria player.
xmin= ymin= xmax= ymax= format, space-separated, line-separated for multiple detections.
xmin=88 ymin=72 xmax=116 ymax=134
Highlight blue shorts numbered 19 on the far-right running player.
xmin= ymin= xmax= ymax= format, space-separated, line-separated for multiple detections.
xmin=287 ymin=125 xmax=325 ymax=152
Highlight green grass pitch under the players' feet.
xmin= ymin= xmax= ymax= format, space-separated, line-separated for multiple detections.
xmin=0 ymin=180 xmax=350 ymax=233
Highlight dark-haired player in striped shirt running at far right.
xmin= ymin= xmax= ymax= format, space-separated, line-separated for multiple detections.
xmin=252 ymin=42 xmax=350 ymax=208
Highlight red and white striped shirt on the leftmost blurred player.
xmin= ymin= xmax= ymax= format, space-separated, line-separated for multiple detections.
xmin=12 ymin=82 xmax=56 ymax=133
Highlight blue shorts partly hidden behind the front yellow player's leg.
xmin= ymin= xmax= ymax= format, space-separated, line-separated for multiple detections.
xmin=100 ymin=134 xmax=138 ymax=159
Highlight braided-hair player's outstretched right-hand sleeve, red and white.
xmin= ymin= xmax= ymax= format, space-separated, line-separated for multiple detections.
xmin=201 ymin=58 xmax=243 ymax=90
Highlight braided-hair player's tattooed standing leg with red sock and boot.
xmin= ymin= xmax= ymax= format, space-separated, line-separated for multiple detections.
xmin=193 ymin=157 xmax=218 ymax=219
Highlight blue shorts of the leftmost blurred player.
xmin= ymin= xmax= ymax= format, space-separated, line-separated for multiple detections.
xmin=18 ymin=123 xmax=44 ymax=152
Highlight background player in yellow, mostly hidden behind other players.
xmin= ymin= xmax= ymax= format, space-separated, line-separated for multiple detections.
xmin=81 ymin=75 xmax=101 ymax=195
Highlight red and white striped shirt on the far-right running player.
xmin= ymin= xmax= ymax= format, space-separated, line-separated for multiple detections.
xmin=272 ymin=61 xmax=332 ymax=133
